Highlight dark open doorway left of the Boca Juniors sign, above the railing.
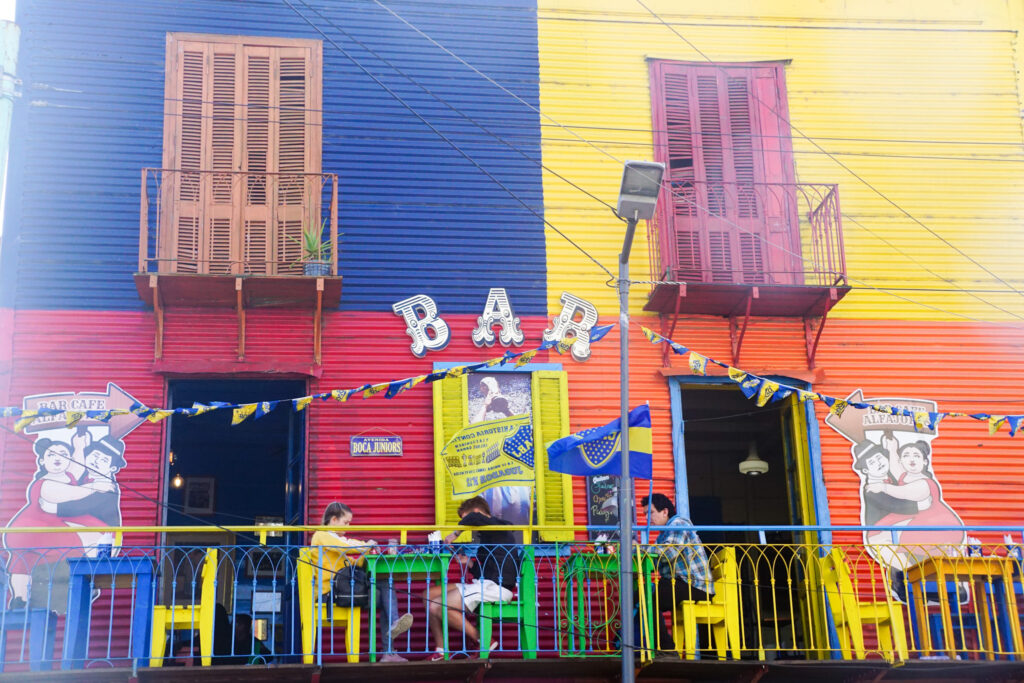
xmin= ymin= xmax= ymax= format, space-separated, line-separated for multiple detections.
xmin=167 ymin=380 xmax=305 ymax=526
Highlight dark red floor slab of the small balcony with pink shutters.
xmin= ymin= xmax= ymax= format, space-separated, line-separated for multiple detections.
xmin=644 ymin=283 xmax=851 ymax=317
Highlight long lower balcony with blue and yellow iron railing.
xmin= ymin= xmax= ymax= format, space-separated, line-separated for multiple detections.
xmin=0 ymin=525 xmax=1024 ymax=680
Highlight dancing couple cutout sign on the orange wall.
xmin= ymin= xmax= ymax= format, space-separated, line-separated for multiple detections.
xmin=825 ymin=389 xmax=966 ymax=570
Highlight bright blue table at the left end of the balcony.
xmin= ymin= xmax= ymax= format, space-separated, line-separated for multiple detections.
xmin=60 ymin=556 xmax=153 ymax=669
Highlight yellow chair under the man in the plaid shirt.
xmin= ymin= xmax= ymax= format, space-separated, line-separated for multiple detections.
xmin=662 ymin=548 xmax=740 ymax=659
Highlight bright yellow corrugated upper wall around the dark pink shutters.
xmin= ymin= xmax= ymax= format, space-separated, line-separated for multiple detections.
xmin=538 ymin=0 xmax=1024 ymax=321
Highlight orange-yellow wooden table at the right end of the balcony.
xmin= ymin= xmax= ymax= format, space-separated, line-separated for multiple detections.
xmin=906 ymin=555 xmax=1024 ymax=659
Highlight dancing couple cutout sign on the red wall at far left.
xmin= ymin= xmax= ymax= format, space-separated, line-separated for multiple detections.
xmin=4 ymin=382 xmax=143 ymax=605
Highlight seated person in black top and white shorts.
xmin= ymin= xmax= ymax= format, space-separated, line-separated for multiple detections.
xmin=423 ymin=496 xmax=519 ymax=661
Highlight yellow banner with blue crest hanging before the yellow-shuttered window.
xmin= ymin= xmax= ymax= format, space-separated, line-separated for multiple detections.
xmin=438 ymin=415 xmax=536 ymax=499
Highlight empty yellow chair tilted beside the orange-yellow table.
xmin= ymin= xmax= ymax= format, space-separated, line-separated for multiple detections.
xmin=818 ymin=548 xmax=909 ymax=661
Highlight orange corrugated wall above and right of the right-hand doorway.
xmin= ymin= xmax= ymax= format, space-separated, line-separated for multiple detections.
xmin=644 ymin=318 xmax=1024 ymax=541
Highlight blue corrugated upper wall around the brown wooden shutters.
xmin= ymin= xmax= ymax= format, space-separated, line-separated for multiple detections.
xmin=0 ymin=0 xmax=546 ymax=314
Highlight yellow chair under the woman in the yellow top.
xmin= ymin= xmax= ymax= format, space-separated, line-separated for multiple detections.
xmin=295 ymin=548 xmax=362 ymax=664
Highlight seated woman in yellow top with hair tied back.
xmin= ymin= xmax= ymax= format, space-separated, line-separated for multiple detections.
xmin=309 ymin=502 xmax=413 ymax=661
